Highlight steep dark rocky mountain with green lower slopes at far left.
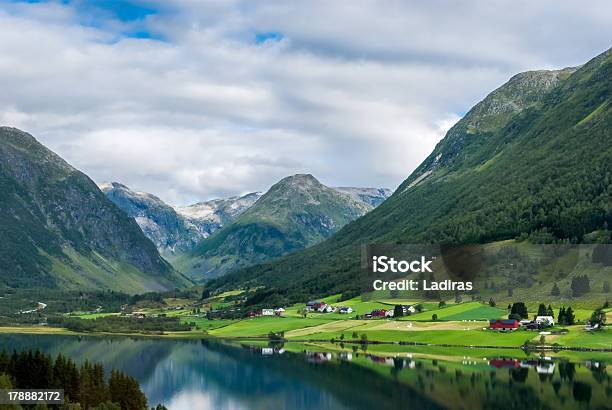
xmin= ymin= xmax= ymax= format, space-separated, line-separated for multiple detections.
xmin=0 ymin=127 xmax=190 ymax=293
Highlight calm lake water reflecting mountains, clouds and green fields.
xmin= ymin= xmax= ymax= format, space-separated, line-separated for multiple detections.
xmin=0 ymin=335 xmax=612 ymax=410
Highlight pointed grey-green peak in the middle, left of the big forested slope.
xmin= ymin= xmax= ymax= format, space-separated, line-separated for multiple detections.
xmin=177 ymin=174 xmax=387 ymax=279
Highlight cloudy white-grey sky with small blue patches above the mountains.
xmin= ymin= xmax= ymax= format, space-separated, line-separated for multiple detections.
xmin=0 ymin=0 xmax=612 ymax=204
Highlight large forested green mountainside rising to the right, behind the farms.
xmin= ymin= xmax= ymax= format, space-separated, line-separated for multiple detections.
xmin=208 ymin=50 xmax=612 ymax=303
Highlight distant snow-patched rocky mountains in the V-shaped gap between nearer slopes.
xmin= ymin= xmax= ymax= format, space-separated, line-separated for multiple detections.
xmin=100 ymin=182 xmax=261 ymax=259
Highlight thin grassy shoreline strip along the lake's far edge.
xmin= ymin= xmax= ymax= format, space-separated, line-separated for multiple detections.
xmin=0 ymin=326 xmax=612 ymax=353
